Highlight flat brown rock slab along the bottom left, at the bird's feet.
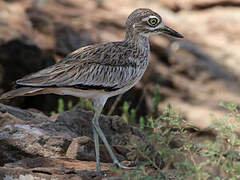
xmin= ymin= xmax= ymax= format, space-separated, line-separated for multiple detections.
xmin=0 ymin=157 xmax=112 ymax=180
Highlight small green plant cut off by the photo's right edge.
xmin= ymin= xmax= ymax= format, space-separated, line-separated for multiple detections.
xmin=201 ymin=103 xmax=240 ymax=179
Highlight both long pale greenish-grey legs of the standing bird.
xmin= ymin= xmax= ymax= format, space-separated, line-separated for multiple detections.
xmin=92 ymin=98 xmax=128 ymax=171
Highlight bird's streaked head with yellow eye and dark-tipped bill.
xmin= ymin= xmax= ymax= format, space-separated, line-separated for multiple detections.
xmin=126 ymin=8 xmax=183 ymax=38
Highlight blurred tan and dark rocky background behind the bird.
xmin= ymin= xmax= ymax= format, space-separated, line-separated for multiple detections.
xmin=0 ymin=0 xmax=240 ymax=129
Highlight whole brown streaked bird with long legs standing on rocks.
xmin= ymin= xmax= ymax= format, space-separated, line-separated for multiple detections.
xmin=0 ymin=8 xmax=183 ymax=173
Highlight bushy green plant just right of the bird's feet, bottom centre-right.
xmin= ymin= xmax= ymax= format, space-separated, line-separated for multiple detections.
xmin=125 ymin=105 xmax=198 ymax=179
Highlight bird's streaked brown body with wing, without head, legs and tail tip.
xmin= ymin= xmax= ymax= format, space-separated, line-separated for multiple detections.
xmin=16 ymin=41 xmax=149 ymax=92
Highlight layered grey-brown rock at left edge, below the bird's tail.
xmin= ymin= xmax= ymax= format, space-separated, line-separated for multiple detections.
xmin=0 ymin=105 xmax=71 ymax=165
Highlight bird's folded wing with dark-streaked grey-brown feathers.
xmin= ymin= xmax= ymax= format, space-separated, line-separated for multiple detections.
xmin=16 ymin=43 xmax=137 ymax=89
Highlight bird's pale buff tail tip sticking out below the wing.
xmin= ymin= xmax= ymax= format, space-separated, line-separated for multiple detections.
xmin=0 ymin=87 xmax=44 ymax=100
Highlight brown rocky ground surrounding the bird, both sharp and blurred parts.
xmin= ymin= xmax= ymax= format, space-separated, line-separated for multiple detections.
xmin=0 ymin=0 xmax=240 ymax=179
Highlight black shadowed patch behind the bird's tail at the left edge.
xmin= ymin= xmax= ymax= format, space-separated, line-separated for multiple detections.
xmin=0 ymin=40 xmax=58 ymax=111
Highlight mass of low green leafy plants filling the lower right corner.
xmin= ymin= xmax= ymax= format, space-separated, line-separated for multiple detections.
xmin=115 ymin=103 xmax=240 ymax=180
